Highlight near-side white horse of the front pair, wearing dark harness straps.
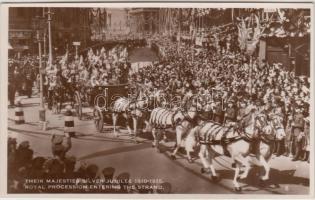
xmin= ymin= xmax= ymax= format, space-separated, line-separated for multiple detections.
xmin=186 ymin=108 xmax=274 ymax=191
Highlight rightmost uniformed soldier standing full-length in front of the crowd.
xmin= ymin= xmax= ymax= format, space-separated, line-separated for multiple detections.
xmin=291 ymin=106 xmax=304 ymax=161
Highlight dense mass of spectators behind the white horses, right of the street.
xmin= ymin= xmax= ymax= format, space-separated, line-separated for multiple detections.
xmin=135 ymin=28 xmax=310 ymax=161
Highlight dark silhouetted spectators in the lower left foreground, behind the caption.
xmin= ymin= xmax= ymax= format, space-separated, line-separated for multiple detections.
xmin=8 ymin=135 xmax=171 ymax=194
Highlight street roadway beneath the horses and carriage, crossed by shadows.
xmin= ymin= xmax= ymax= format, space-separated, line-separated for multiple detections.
xmin=8 ymin=49 xmax=310 ymax=195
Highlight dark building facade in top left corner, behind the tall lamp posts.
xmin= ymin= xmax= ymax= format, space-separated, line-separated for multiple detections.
xmin=9 ymin=7 xmax=90 ymax=55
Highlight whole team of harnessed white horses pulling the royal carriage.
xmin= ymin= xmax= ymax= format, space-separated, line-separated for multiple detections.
xmin=111 ymin=91 xmax=284 ymax=191
